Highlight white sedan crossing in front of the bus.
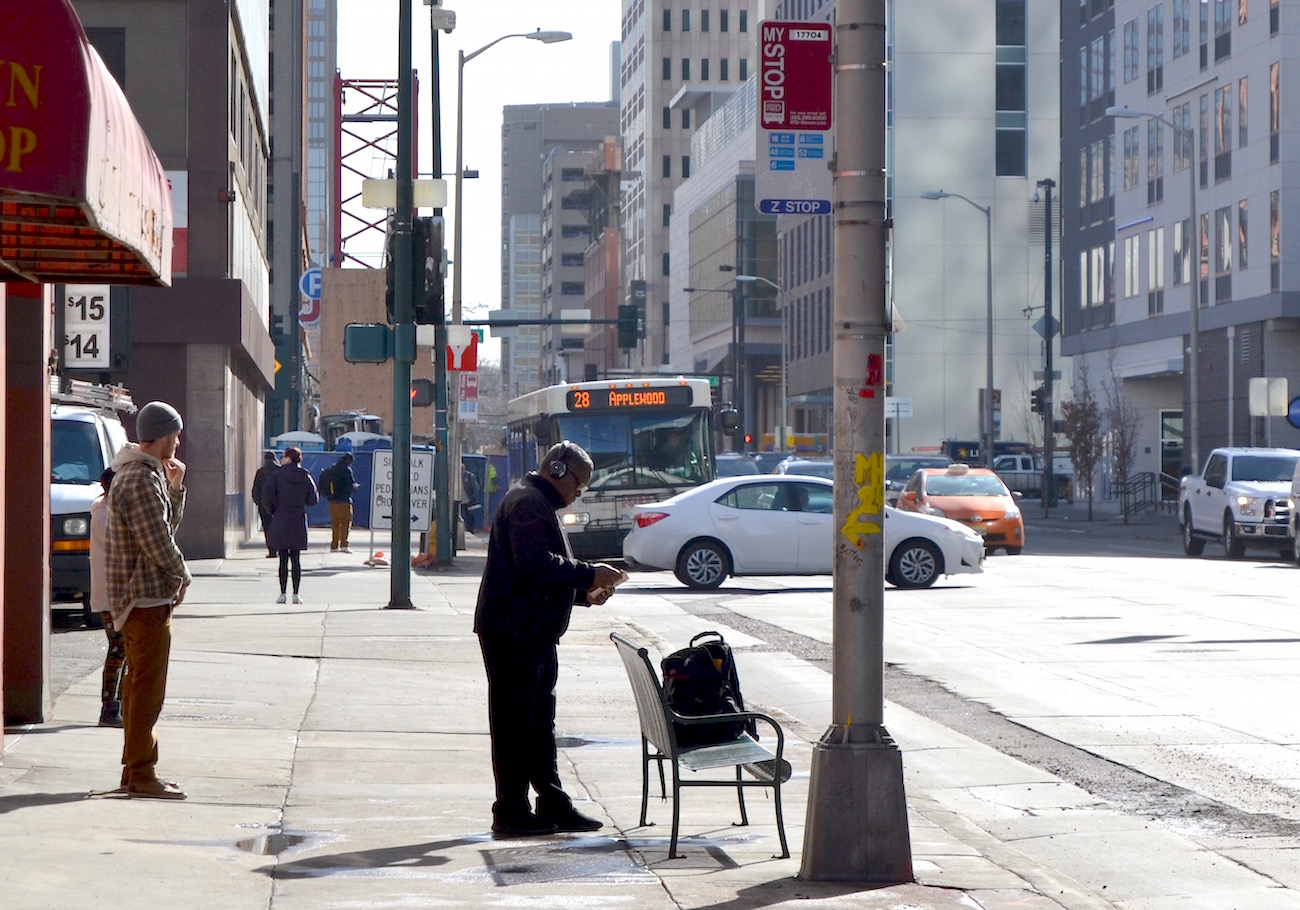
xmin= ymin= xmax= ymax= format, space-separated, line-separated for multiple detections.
xmin=623 ymin=475 xmax=984 ymax=589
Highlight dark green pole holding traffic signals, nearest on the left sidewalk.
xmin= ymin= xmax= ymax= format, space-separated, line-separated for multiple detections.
xmin=389 ymin=0 xmax=416 ymax=610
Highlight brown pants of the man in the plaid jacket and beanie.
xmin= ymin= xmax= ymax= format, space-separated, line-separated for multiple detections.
xmin=122 ymin=607 xmax=172 ymax=787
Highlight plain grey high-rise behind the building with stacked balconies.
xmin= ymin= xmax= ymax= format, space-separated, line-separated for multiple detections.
xmin=491 ymin=101 xmax=619 ymax=395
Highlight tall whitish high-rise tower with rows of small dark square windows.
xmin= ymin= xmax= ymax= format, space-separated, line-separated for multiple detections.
xmin=619 ymin=0 xmax=771 ymax=369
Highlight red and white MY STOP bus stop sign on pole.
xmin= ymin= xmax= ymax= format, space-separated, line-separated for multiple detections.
xmin=755 ymin=20 xmax=832 ymax=215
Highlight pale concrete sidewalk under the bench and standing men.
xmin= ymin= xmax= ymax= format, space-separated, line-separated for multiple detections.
xmin=0 ymin=530 xmax=1206 ymax=910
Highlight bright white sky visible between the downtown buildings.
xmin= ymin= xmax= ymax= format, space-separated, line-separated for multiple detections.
xmin=338 ymin=0 xmax=623 ymax=360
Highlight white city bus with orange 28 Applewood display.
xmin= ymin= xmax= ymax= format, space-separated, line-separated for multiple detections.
xmin=506 ymin=377 xmax=716 ymax=559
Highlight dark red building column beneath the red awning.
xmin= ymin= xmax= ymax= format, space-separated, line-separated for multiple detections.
xmin=0 ymin=283 xmax=52 ymax=724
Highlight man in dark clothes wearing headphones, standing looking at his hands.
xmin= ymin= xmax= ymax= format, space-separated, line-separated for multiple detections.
xmin=475 ymin=439 xmax=624 ymax=837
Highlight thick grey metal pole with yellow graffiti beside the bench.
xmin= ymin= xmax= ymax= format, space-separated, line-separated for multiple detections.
xmin=800 ymin=0 xmax=913 ymax=883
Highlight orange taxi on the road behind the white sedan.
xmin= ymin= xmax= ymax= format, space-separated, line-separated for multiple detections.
xmin=898 ymin=464 xmax=1024 ymax=556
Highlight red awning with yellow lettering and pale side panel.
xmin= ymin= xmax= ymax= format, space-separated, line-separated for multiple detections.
xmin=0 ymin=0 xmax=172 ymax=285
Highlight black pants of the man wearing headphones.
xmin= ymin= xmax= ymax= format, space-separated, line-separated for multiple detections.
xmin=478 ymin=633 xmax=572 ymax=818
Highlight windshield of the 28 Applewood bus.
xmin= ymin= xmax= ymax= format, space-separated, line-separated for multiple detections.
xmin=556 ymin=411 xmax=712 ymax=491
